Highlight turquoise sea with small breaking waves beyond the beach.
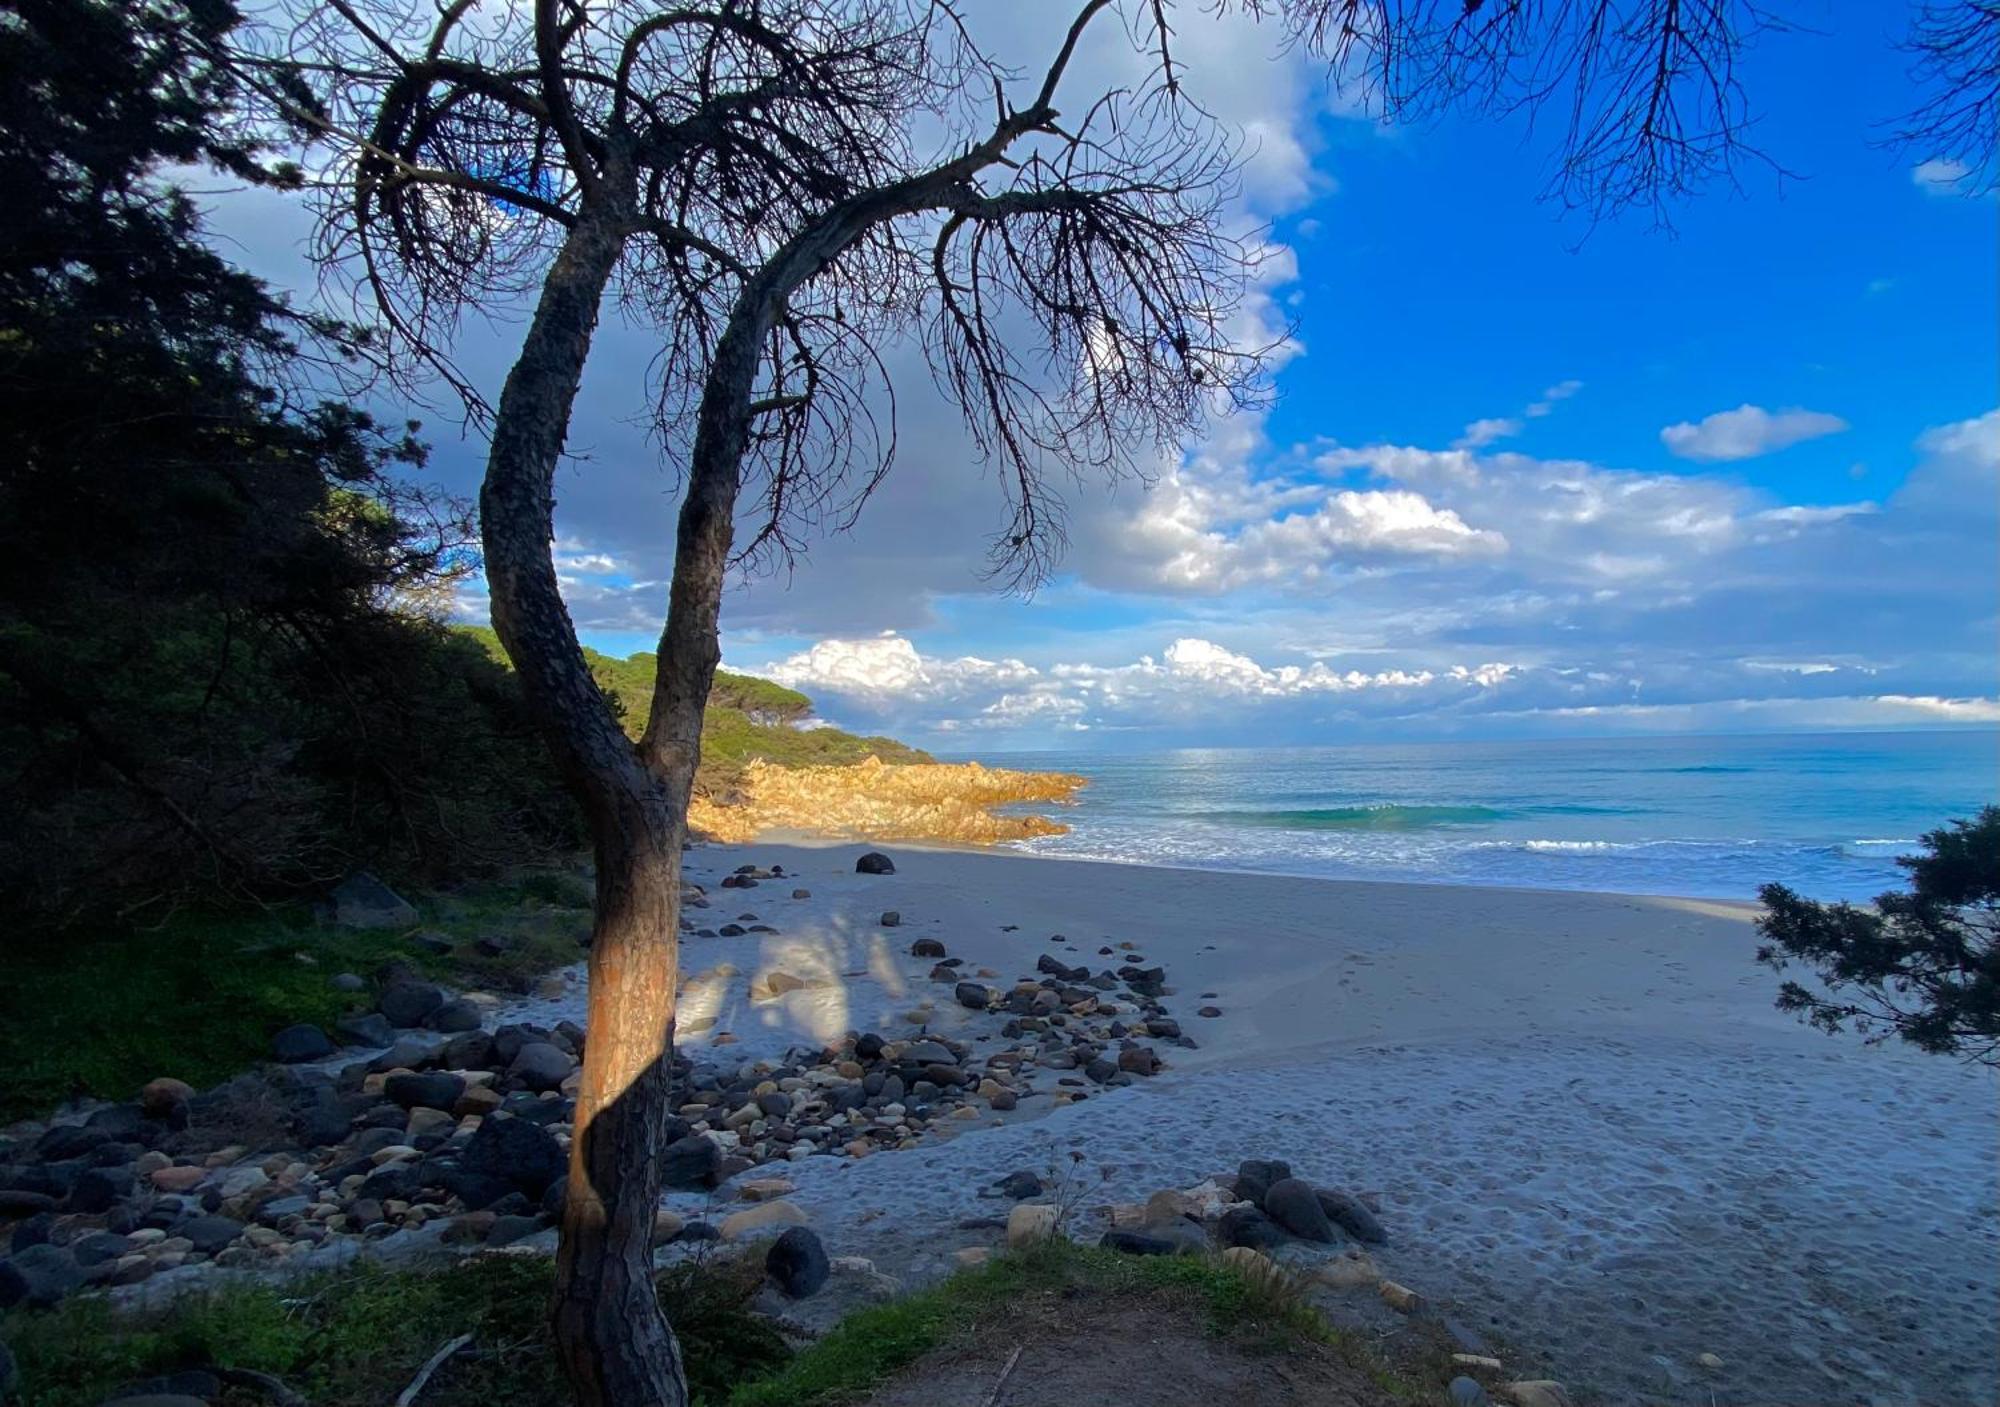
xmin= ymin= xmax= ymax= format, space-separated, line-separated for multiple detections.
xmin=980 ymin=731 xmax=2000 ymax=899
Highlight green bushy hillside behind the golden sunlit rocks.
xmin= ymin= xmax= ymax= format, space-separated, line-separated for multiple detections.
xmin=458 ymin=626 xmax=932 ymax=801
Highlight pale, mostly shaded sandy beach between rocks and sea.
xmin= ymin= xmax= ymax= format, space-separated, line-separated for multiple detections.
xmin=514 ymin=845 xmax=2000 ymax=1405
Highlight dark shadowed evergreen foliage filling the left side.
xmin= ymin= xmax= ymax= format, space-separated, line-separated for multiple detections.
xmin=0 ymin=0 xmax=574 ymax=919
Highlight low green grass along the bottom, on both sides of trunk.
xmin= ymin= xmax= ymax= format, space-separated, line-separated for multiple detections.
xmin=11 ymin=1241 xmax=1412 ymax=1407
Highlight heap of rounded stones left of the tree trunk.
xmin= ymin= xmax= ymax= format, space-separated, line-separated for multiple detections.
xmin=0 ymin=1001 xmax=584 ymax=1307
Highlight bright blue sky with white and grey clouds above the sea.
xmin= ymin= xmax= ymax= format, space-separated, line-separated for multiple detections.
xmin=216 ymin=2 xmax=2000 ymax=751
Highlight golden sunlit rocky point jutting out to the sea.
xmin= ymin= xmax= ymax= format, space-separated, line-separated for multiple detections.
xmin=688 ymin=757 xmax=1084 ymax=845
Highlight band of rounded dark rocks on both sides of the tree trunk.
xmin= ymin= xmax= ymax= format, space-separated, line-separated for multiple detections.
xmin=0 ymin=865 xmax=1184 ymax=1307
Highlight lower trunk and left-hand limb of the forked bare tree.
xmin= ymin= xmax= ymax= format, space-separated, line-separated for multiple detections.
xmin=480 ymin=212 xmax=692 ymax=1407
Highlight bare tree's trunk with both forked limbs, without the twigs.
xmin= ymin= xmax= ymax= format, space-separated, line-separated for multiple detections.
xmin=480 ymin=180 xmax=910 ymax=1407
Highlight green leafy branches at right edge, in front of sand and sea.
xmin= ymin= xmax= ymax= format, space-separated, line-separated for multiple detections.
xmin=1756 ymin=805 xmax=2000 ymax=1065
